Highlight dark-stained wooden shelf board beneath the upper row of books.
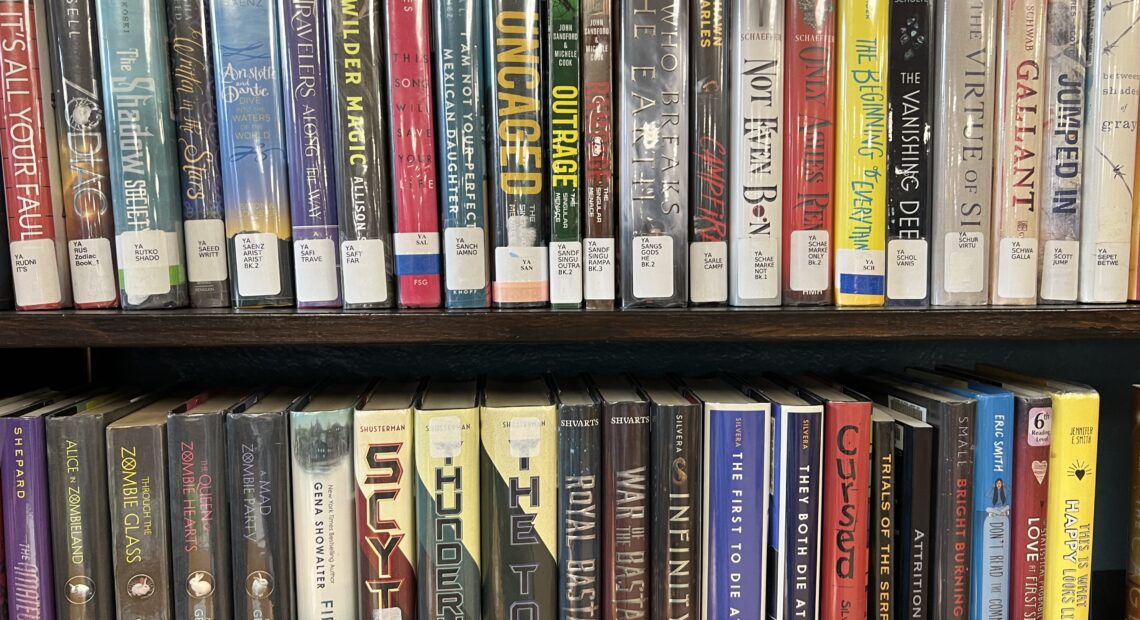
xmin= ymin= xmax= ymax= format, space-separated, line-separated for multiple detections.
xmin=0 ymin=305 xmax=1140 ymax=348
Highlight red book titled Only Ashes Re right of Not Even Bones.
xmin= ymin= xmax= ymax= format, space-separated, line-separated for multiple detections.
xmin=782 ymin=0 xmax=836 ymax=305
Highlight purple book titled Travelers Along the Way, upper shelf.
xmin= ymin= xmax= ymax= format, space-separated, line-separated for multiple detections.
xmin=280 ymin=0 xmax=341 ymax=308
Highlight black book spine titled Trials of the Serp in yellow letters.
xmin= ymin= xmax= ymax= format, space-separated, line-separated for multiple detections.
xmin=866 ymin=419 xmax=905 ymax=620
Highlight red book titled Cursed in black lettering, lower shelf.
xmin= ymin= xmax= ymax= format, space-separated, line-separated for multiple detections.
xmin=795 ymin=377 xmax=871 ymax=620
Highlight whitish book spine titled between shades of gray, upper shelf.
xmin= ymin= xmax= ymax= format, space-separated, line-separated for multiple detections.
xmin=1080 ymin=0 xmax=1140 ymax=303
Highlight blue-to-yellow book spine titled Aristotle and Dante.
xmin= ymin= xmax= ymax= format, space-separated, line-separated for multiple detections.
xmin=210 ymin=0 xmax=293 ymax=308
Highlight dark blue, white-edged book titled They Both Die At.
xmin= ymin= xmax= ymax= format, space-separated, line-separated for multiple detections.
xmin=752 ymin=380 xmax=823 ymax=620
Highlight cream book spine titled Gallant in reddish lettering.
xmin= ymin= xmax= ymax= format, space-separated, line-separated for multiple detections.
xmin=990 ymin=0 xmax=1045 ymax=305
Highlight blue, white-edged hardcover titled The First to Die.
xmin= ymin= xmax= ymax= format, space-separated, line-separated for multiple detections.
xmin=688 ymin=380 xmax=772 ymax=619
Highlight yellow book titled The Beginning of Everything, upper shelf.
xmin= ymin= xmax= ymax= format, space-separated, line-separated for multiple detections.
xmin=836 ymin=0 xmax=890 ymax=305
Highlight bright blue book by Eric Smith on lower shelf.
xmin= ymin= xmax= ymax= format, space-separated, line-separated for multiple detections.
xmin=906 ymin=368 xmax=1015 ymax=620
